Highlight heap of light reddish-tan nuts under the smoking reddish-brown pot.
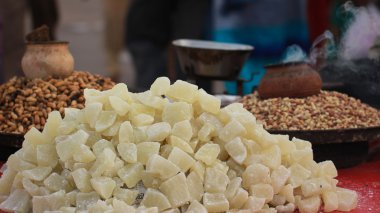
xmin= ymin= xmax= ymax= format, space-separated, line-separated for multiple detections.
xmin=240 ymin=91 xmax=380 ymax=130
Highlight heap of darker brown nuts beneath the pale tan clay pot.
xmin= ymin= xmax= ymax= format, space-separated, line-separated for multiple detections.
xmin=0 ymin=71 xmax=114 ymax=134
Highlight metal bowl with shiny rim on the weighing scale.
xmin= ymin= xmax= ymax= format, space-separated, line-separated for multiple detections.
xmin=172 ymin=39 xmax=253 ymax=80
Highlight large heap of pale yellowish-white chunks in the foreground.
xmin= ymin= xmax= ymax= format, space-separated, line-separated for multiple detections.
xmin=0 ymin=77 xmax=357 ymax=213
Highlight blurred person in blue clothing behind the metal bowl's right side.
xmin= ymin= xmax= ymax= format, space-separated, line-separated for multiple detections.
xmin=213 ymin=0 xmax=310 ymax=94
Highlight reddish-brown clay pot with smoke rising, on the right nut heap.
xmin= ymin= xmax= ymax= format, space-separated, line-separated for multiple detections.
xmin=258 ymin=62 xmax=322 ymax=99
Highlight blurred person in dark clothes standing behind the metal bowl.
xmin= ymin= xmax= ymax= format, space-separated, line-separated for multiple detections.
xmin=126 ymin=0 xmax=211 ymax=91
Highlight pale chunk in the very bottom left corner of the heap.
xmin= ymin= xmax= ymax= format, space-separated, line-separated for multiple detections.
xmin=0 ymin=189 xmax=31 ymax=213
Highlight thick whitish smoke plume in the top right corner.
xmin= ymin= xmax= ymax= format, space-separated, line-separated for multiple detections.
xmin=339 ymin=2 xmax=380 ymax=60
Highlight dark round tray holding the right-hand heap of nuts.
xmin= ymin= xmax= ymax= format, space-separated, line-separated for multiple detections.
xmin=268 ymin=126 xmax=380 ymax=168
